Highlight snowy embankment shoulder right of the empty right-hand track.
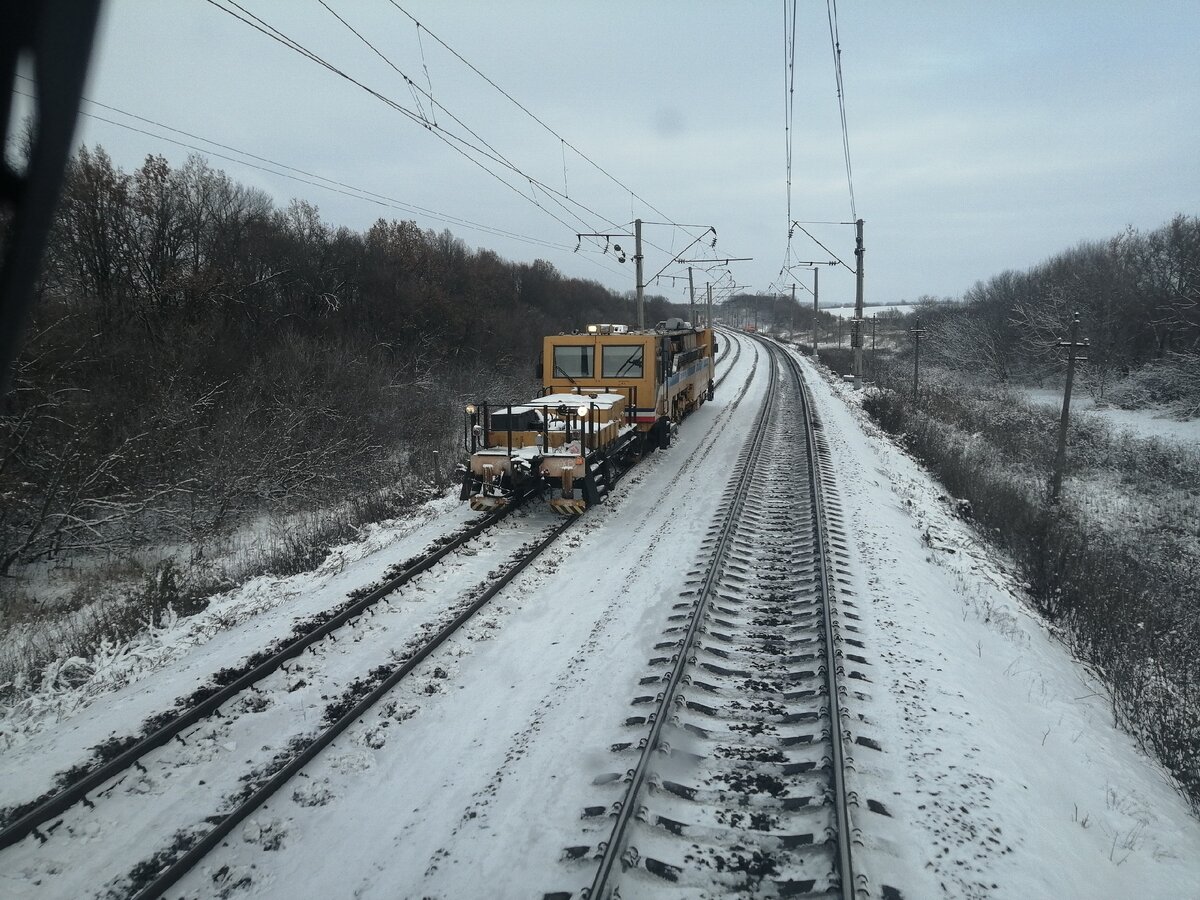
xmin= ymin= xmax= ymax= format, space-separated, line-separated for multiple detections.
xmin=805 ymin=355 xmax=1200 ymax=899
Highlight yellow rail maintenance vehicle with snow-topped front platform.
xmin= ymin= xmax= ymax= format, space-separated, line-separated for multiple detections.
xmin=461 ymin=319 xmax=716 ymax=516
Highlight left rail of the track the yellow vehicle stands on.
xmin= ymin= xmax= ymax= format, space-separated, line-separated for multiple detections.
xmin=0 ymin=506 xmax=515 ymax=850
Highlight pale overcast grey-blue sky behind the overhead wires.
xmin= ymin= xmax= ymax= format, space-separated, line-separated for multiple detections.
xmin=60 ymin=0 xmax=1200 ymax=304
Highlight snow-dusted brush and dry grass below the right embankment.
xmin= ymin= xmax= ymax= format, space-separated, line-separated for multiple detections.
xmin=863 ymin=373 xmax=1200 ymax=805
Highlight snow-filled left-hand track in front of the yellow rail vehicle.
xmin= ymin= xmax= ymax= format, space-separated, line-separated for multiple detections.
xmin=0 ymin=515 xmax=574 ymax=898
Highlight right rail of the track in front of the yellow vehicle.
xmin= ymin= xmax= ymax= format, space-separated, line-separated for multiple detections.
xmin=131 ymin=518 xmax=577 ymax=900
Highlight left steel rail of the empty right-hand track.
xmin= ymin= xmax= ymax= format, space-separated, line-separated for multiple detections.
xmin=587 ymin=340 xmax=776 ymax=900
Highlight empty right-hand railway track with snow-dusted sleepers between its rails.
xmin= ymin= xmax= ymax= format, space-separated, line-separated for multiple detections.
xmin=547 ymin=340 xmax=854 ymax=900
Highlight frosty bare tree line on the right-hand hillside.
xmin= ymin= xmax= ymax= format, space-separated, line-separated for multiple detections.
xmin=917 ymin=215 xmax=1200 ymax=413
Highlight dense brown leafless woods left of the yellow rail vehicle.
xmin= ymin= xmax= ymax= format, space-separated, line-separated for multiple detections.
xmin=0 ymin=148 xmax=674 ymax=575
